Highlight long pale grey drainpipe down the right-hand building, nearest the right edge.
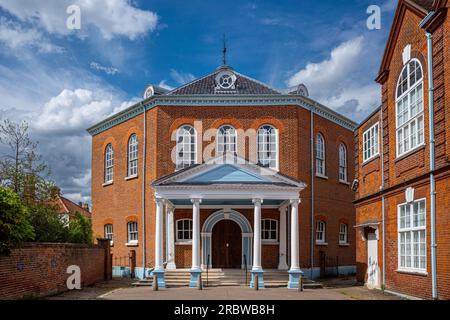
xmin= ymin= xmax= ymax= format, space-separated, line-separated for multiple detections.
xmin=419 ymin=11 xmax=438 ymax=299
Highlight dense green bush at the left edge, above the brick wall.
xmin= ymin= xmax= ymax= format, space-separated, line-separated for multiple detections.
xmin=0 ymin=187 xmax=34 ymax=255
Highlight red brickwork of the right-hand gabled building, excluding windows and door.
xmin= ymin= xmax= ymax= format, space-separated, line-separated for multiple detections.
xmin=355 ymin=1 xmax=450 ymax=299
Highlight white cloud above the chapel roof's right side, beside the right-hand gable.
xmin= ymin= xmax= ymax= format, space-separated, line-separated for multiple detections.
xmin=286 ymin=36 xmax=380 ymax=120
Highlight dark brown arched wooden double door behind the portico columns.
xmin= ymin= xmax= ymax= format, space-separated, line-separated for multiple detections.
xmin=211 ymin=220 xmax=242 ymax=269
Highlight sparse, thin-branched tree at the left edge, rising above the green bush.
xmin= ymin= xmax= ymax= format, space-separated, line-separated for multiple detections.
xmin=0 ymin=120 xmax=54 ymax=204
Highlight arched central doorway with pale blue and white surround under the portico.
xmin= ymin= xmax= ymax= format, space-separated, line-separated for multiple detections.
xmin=201 ymin=210 xmax=253 ymax=269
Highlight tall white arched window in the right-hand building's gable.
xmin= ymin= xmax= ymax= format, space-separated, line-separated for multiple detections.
xmin=396 ymin=59 xmax=424 ymax=157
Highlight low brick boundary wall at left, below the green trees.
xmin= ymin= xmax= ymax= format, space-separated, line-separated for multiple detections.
xmin=0 ymin=243 xmax=111 ymax=299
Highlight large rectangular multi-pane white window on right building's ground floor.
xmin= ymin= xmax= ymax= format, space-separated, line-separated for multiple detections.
xmin=398 ymin=199 xmax=426 ymax=271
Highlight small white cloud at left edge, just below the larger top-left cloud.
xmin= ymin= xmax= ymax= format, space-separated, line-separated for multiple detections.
xmin=0 ymin=17 xmax=64 ymax=53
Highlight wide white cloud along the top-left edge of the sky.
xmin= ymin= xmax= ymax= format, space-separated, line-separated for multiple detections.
xmin=0 ymin=0 xmax=158 ymax=40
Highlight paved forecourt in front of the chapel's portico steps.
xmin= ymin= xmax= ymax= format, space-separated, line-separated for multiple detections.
xmin=46 ymin=278 xmax=400 ymax=300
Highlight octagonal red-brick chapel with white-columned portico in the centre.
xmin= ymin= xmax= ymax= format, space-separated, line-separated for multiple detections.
xmin=88 ymin=66 xmax=356 ymax=286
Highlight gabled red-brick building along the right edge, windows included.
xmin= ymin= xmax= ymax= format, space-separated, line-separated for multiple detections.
xmin=355 ymin=0 xmax=450 ymax=299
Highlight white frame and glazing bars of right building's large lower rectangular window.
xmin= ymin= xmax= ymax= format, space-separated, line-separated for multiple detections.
xmin=397 ymin=198 xmax=427 ymax=274
